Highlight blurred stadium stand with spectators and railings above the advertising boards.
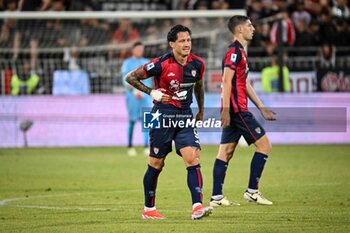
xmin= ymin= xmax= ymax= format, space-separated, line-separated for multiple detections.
xmin=0 ymin=0 xmax=350 ymax=94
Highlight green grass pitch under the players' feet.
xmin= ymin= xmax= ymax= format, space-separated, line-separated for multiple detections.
xmin=0 ymin=145 xmax=350 ymax=233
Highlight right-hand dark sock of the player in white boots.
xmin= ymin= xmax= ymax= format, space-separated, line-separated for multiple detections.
xmin=248 ymin=152 xmax=268 ymax=191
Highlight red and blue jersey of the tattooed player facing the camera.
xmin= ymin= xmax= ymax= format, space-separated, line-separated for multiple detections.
xmin=143 ymin=52 xmax=205 ymax=109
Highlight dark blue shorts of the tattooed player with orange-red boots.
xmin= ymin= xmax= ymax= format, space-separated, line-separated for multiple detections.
xmin=149 ymin=104 xmax=200 ymax=158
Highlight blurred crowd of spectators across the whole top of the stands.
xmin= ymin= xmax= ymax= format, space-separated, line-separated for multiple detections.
xmin=0 ymin=0 xmax=350 ymax=67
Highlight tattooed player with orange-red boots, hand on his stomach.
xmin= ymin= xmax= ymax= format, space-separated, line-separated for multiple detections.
xmin=127 ymin=25 xmax=212 ymax=219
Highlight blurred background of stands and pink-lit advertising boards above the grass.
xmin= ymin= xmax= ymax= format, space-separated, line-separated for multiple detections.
xmin=0 ymin=0 xmax=350 ymax=147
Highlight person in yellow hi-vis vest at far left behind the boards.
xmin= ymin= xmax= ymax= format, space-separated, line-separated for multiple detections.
xmin=11 ymin=62 xmax=40 ymax=96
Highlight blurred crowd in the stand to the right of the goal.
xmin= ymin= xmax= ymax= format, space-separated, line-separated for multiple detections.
xmin=247 ymin=0 xmax=350 ymax=66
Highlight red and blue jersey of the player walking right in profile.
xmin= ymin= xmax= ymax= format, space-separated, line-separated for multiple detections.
xmin=221 ymin=40 xmax=249 ymax=112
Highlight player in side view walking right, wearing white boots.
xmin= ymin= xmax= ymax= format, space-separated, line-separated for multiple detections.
xmin=210 ymin=15 xmax=275 ymax=206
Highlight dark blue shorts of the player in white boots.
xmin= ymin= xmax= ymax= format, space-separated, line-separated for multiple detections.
xmin=220 ymin=112 xmax=265 ymax=145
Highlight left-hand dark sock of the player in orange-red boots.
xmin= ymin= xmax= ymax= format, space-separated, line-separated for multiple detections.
xmin=143 ymin=165 xmax=161 ymax=208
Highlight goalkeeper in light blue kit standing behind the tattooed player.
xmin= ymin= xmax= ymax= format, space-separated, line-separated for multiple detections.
xmin=122 ymin=42 xmax=152 ymax=156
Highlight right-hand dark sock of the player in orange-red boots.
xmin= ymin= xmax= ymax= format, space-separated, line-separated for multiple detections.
xmin=187 ymin=164 xmax=203 ymax=204
